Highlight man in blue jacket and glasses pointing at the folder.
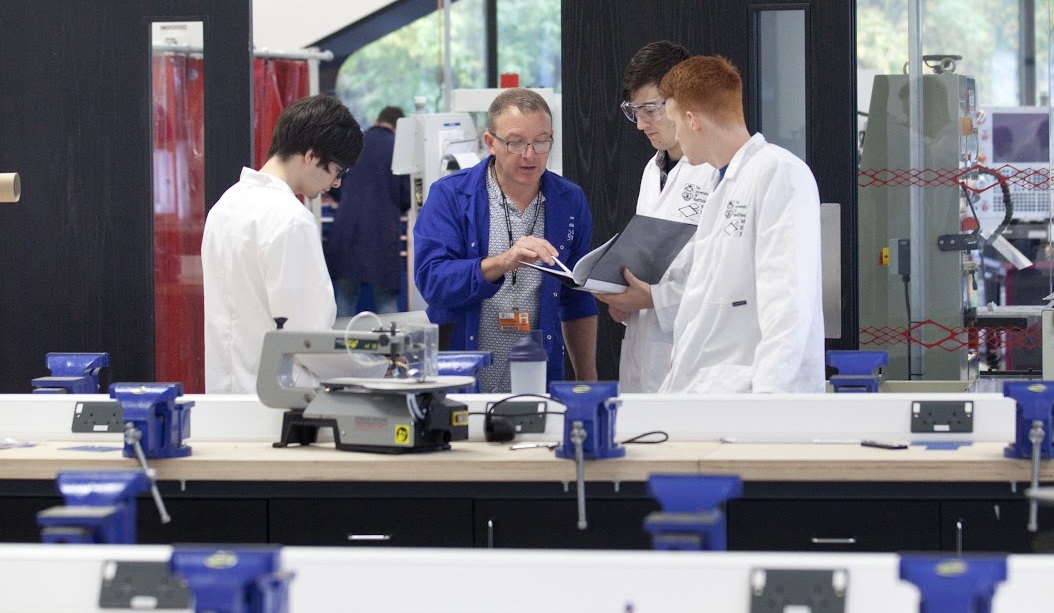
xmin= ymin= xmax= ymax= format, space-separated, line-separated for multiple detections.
xmin=413 ymin=88 xmax=599 ymax=393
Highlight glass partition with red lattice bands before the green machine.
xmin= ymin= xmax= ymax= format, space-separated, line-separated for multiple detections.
xmin=857 ymin=0 xmax=1054 ymax=380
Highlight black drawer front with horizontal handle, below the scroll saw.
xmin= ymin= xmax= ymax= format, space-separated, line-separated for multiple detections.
xmin=269 ymin=498 xmax=472 ymax=547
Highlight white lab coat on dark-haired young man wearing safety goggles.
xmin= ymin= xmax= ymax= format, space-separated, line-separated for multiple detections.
xmin=619 ymin=153 xmax=717 ymax=393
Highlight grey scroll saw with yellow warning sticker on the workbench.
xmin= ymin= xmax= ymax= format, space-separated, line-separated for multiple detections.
xmin=256 ymin=322 xmax=475 ymax=453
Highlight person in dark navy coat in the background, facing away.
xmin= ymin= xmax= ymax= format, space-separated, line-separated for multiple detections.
xmin=325 ymin=106 xmax=410 ymax=317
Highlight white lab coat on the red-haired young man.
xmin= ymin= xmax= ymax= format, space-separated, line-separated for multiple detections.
xmin=661 ymin=134 xmax=824 ymax=393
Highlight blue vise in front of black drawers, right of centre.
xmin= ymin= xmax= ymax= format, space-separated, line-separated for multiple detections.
xmin=644 ymin=475 xmax=743 ymax=551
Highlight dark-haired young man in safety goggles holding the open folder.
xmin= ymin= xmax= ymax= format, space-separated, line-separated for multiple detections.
xmin=597 ymin=40 xmax=717 ymax=393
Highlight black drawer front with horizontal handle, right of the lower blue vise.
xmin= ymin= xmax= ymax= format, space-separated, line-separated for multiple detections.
xmin=727 ymin=499 xmax=940 ymax=552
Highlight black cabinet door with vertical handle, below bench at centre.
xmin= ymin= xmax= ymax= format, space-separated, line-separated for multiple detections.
xmin=475 ymin=499 xmax=659 ymax=549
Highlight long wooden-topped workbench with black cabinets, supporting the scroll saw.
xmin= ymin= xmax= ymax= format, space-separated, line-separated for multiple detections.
xmin=0 ymin=397 xmax=1054 ymax=552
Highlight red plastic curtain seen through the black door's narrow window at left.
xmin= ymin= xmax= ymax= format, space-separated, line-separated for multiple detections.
xmin=153 ymin=54 xmax=204 ymax=393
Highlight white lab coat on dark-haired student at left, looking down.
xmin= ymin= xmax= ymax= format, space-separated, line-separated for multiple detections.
xmin=201 ymin=169 xmax=336 ymax=394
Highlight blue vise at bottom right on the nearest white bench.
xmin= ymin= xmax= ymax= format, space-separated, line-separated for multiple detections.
xmin=900 ymin=555 xmax=1007 ymax=613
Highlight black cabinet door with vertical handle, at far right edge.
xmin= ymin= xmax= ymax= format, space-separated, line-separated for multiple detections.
xmin=940 ymin=499 xmax=1054 ymax=553
